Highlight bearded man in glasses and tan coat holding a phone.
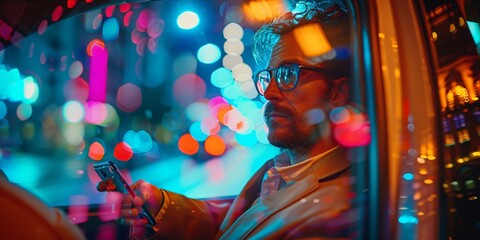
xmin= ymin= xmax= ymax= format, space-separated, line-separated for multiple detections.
xmin=98 ymin=1 xmax=354 ymax=239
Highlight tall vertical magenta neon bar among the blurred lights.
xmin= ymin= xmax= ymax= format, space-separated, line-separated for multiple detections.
xmin=87 ymin=39 xmax=108 ymax=102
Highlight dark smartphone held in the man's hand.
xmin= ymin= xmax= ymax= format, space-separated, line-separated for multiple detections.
xmin=93 ymin=161 xmax=156 ymax=226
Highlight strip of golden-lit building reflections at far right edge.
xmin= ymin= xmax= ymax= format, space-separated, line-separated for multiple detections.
xmin=425 ymin=1 xmax=480 ymax=239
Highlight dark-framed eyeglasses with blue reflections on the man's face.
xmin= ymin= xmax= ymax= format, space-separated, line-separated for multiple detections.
xmin=254 ymin=63 xmax=329 ymax=95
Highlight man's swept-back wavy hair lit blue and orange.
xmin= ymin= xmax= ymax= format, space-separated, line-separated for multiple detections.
xmin=252 ymin=0 xmax=351 ymax=76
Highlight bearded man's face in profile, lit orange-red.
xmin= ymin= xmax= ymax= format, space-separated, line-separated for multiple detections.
xmin=264 ymin=33 xmax=338 ymax=149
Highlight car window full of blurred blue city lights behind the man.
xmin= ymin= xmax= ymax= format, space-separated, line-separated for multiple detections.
xmin=0 ymin=1 xmax=279 ymax=205
